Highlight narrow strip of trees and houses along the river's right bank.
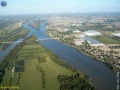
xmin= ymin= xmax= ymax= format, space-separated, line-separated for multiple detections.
xmin=45 ymin=30 xmax=117 ymax=72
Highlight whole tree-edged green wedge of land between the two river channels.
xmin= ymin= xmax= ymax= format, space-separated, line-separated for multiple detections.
xmin=0 ymin=36 xmax=95 ymax=90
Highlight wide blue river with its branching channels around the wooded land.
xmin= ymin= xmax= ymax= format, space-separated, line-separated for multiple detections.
xmin=0 ymin=22 xmax=117 ymax=90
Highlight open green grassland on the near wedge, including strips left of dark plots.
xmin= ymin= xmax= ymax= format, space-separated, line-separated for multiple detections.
xmin=1 ymin=36 xmax=73 ymax=90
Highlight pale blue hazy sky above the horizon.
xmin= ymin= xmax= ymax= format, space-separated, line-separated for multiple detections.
xmin=0 ymin=0 xmax=120 ymax=15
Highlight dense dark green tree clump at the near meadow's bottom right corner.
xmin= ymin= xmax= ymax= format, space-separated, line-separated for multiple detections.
xmin=57 ymin=73 xmax=96 ymax=90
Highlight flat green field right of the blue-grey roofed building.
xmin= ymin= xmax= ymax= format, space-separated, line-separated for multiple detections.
xmin=93 ymin=35 xmax=120 ymax=44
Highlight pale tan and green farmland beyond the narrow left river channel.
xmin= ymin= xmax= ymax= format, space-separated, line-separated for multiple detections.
xmin=0 ymin=21 xmax=28 ymax=50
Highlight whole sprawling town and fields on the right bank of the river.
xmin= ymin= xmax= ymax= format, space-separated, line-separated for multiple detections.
xmin=46 ymin=14 xmax=120 ymax=71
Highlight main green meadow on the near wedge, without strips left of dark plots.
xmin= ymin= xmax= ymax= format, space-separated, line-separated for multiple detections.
xmin=18 ymin=44 xmax=73 ymax=90
